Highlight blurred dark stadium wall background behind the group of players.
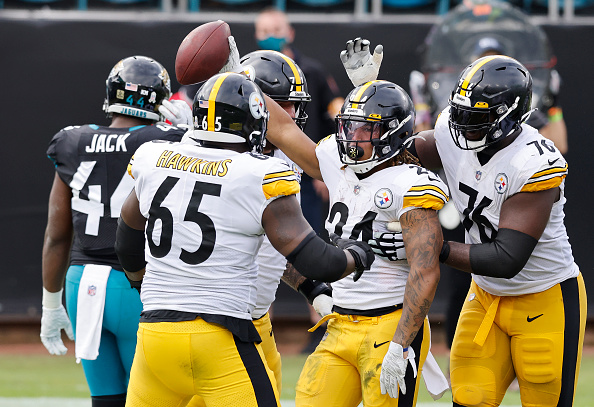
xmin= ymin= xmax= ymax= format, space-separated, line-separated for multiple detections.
xmin=0 ymin=0 xmax=594 ymax=350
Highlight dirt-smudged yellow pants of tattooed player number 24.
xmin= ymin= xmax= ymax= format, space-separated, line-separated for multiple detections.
xmin=295 ymin=310 xmax=431 ymax=407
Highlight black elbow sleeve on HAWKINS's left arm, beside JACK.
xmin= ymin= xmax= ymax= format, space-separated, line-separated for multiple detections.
xmin=114 ymin=218 xmax=146 ymax=272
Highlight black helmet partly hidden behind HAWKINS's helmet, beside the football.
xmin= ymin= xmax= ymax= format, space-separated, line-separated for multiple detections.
xmin=239 ymin=51 xmax=311 ymax=130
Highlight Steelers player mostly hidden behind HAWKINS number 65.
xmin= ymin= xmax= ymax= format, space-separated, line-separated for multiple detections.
xmin=188 ymin=51 xmax=332 ymax=407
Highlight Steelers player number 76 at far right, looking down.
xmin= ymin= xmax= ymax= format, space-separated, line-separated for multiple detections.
xmin=346 ymin=45 xmax=587 ymax=406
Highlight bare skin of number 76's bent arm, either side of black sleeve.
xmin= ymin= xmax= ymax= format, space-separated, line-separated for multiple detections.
xmin=445 ymin=188 xmax=560 ymax=273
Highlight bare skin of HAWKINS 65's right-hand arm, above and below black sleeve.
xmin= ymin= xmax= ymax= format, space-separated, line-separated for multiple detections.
xmin=262 ymin=195 xmax=355 ymax=278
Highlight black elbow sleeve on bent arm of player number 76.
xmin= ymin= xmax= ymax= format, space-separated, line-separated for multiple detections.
xmin=470 ymin=229 xmax=538 ymax=278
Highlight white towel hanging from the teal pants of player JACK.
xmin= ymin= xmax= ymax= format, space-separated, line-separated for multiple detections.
xmin=74 ymin=264 xmax=111 ymax=363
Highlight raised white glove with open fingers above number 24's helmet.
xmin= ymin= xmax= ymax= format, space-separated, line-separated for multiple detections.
xmin=340 ymin=37 xmax=384 ymax=86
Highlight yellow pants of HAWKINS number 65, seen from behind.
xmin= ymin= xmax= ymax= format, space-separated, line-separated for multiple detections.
xmin=126 ymin=318 xmax=280 ymax=407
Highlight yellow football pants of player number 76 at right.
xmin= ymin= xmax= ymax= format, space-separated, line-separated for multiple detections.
xmin=450 ymin=274 xmax=587 ymax=407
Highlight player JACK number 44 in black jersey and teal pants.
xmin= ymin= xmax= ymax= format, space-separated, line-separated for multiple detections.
xmin=41 ymin=56 xmax=184 ymax=407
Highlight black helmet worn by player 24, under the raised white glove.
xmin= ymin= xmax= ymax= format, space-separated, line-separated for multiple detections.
xmin=336 ymin=81 xmax=415 ymax=174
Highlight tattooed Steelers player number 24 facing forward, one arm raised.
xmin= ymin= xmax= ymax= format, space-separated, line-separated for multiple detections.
xmin=262 ymin=81 xmax=448 ymax=406
